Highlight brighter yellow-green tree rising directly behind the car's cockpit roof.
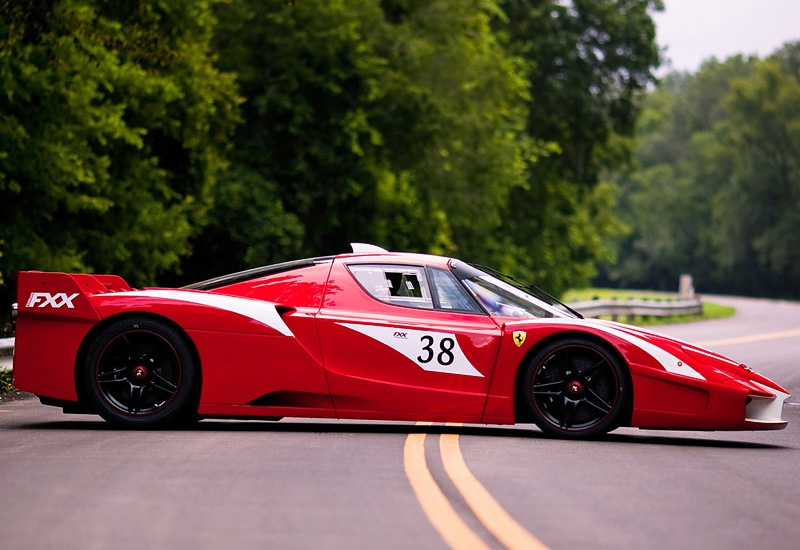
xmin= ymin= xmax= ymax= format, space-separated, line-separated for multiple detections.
xmin=371 ymin=0 xmax=536 ymax=261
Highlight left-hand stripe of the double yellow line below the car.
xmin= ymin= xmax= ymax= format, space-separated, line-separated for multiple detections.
xmin=403 ymin=422 xmax=489 ymax=550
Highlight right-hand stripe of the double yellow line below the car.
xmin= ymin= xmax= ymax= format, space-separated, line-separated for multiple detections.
xmin=439 ymin=434 xmax=547 ymax=550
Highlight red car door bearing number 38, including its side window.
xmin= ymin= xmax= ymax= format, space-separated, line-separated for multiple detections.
xmin=317 ymin=260 xmax=501 ymax=422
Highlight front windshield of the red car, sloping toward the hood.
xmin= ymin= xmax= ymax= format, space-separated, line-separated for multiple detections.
xmin=463 ymin=274 xmax=573 ymax=318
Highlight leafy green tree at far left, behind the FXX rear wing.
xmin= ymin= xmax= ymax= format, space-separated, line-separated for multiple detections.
xmin=0 ymin=0 xmax=239 ymax=304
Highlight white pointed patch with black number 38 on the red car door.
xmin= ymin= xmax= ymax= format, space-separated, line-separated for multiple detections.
xmin=338 ymin=323 xmax=483 ymax=378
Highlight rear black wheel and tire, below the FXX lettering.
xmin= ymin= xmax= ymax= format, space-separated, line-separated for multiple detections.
xmin=83 ymin=317 xmax=199 ymax=428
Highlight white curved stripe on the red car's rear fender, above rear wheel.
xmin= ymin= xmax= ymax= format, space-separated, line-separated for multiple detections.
xmin=108 ymin=290 xmax=294 ymax=336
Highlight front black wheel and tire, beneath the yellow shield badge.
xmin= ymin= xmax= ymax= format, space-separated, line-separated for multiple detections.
xmin=524 ymin=337 xmax=630 ymax=439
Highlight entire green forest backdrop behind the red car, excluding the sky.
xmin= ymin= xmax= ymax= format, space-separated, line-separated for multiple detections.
xmin=0 ymin=0 xmax=800 ymax=320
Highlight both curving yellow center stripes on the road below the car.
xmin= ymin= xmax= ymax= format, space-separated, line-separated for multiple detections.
xmin=403 ymin=422 xmax=547 ymax=550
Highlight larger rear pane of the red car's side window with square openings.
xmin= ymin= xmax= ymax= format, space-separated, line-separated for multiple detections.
xmin=347 ymin=265 xmax=433 ymax=309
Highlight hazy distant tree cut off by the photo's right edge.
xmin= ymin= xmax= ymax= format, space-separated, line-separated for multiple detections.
xmin=711 ymin=55 xmax=800 ymax=297
